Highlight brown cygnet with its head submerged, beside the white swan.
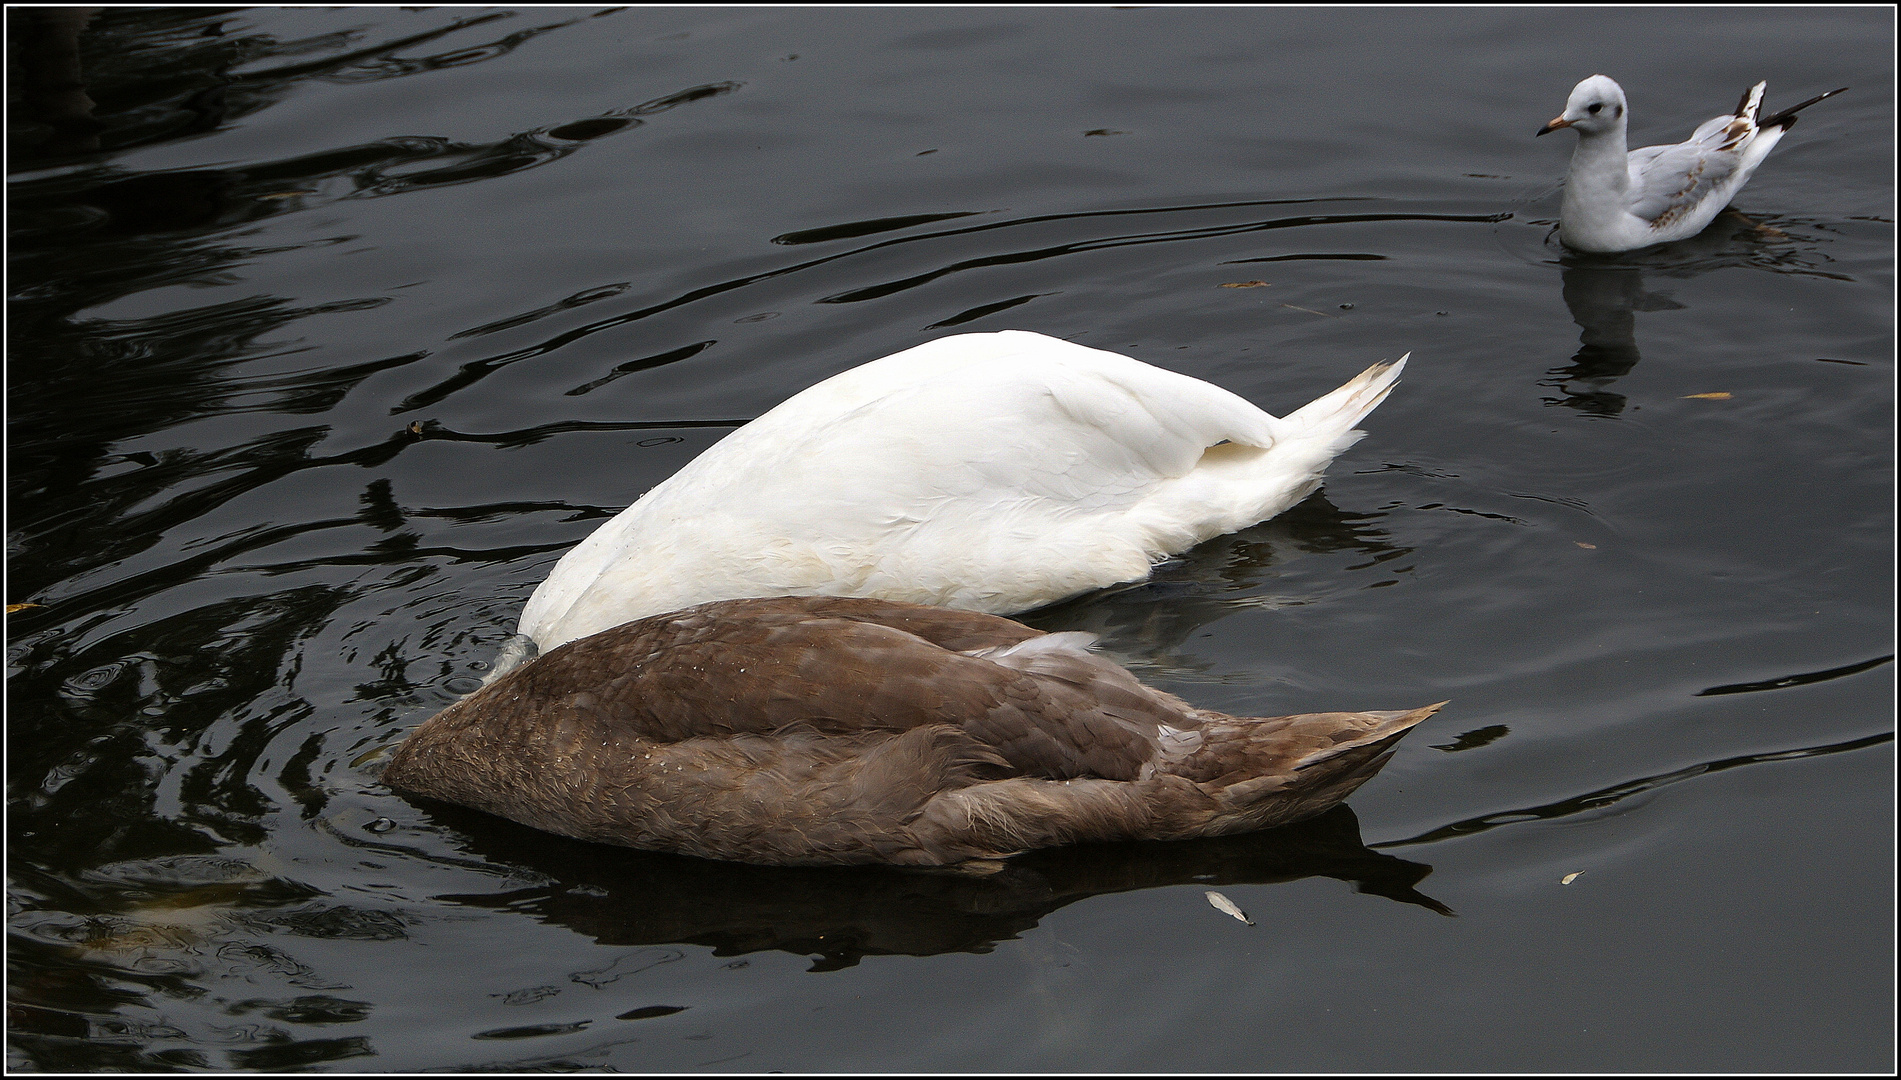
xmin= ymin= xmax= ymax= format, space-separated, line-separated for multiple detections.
xmin=384 ymin=597 xmax=1445 ymax=865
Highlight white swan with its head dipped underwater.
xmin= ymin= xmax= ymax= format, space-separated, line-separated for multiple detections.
xmin=513 ymin=331 xmax=1405 ymax=657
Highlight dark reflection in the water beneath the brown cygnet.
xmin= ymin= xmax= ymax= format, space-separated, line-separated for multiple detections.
xmin=426 ymin=802 xmax=1452 ymax=972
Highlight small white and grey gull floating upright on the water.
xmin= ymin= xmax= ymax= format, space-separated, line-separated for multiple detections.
xmin=1538 ymin=74 xmax=1848 ymax=251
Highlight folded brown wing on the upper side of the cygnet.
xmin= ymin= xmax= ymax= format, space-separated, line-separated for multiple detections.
xmin=490 ymin=599 xmax=1200 ymax=780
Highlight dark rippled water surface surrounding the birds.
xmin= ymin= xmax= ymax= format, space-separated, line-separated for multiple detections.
xmin=6 ymin=8 xmax=1895 ymax=1070
